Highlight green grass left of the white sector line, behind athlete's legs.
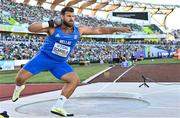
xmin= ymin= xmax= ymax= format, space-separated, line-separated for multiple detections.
xmin=0 ymin=64 xmax=109 ymax=83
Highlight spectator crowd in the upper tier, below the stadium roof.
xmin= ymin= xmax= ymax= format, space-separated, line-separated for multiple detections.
xmin=0 ymin=0 xmax=162 ymax=33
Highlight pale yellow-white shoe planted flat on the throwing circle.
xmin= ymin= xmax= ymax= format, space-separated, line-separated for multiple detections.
xmin=51 ymin=107 xmax=74 ymax=117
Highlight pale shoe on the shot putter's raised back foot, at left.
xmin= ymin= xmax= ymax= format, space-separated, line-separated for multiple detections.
xmin=12 ymin=85 xmax=25 ymax=102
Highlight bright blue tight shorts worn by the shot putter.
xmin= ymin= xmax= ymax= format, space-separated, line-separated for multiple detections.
xmin=23 ymin=52 xmax=74 ymax=79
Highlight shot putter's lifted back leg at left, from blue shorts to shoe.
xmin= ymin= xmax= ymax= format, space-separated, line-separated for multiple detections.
xmin=12 ymin=53 xmax=52 ymax=102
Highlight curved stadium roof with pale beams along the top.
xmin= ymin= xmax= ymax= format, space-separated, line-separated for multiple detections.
xmin=19 ymin=0 xmax=180 ymax=29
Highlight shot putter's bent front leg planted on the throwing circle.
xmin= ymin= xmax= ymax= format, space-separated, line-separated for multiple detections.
xmin=51 ymin=62 xmax=80 ymax=116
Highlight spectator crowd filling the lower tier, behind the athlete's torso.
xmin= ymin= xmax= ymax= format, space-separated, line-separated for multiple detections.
xmin=0 ymin=33 xmax=180 ymax=63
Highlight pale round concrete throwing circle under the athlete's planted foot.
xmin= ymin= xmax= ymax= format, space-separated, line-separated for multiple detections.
xmin=16 ymin=93 xmax=149 ymax=117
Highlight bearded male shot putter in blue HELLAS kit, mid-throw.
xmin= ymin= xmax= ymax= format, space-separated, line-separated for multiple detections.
xmin=12 ymin=7 xmax=130 ymax=117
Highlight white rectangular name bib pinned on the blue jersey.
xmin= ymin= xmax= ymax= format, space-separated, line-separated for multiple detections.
xmin=52 ymin=43 xmax=70 ymax=57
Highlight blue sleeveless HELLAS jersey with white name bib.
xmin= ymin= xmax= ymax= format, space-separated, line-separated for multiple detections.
xmin=40 ymin=26 xmax=80 ymax=61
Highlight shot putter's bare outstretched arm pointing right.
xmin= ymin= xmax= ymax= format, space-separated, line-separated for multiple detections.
xmin=79 ymin=27 xmax=131 ymax=35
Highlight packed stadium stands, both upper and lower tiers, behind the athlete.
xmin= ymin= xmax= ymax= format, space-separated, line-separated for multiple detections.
xmin=0 ymin=0 xmax=180 ymax=63
